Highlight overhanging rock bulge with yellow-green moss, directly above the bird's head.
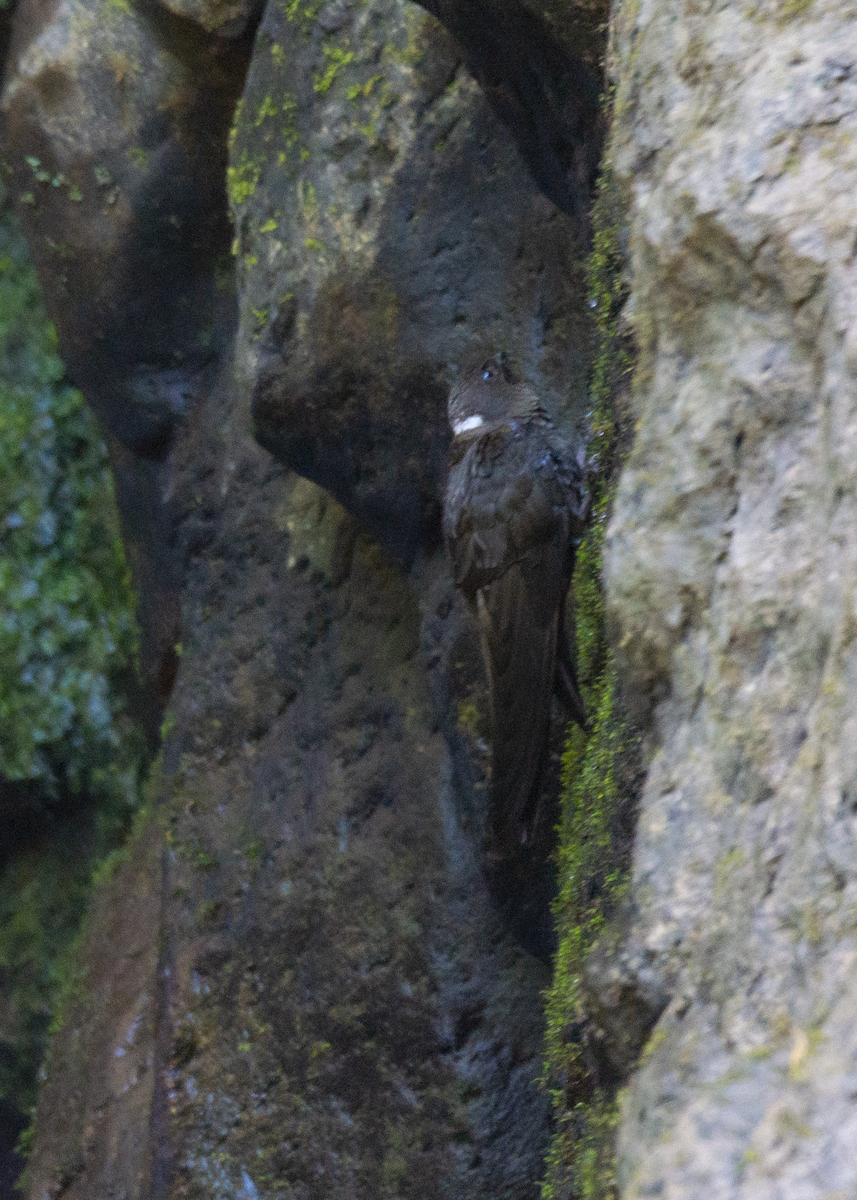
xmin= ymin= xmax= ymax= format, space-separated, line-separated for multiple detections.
xmin=229 ymin=0 xmax=589 ymax=559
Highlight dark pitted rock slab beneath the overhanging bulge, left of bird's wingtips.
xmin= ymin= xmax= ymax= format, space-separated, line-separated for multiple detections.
xmin=25 ymin=376 xmax=550 ymax=1200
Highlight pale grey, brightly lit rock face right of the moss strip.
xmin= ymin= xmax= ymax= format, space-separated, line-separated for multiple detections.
xmin=606 ymin=0 xmax=857 ymax=1200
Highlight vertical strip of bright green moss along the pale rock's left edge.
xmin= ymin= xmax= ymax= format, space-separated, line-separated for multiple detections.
xmin=541 ymin=172 xmax=636 ymax=1200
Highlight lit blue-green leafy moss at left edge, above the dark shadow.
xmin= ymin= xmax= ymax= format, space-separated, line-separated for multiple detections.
xmin=0 ymin=192 xmax=137 ymax=793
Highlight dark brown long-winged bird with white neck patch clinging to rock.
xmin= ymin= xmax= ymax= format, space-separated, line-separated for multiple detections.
xmin=443 ymin=354 xmax=588 ymax=860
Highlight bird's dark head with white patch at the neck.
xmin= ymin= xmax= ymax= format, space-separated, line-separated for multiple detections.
xmin=447 ymin=354 xmax=540 ymax=437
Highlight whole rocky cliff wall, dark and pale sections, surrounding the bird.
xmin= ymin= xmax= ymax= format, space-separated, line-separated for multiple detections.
xmin=11 ymin=0 xmax=857 ymax=1200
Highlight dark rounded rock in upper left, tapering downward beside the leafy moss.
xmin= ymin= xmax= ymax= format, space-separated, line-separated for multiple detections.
xmin=2 ymin=0 xmax=248 ymax=704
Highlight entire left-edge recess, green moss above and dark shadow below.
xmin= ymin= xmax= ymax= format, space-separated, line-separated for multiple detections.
xmin=0 ymin=187 xmax=145 ymax=1132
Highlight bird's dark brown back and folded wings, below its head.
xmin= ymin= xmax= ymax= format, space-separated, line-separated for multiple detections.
xmin=444 ymin=430 xmax=586 ymax=857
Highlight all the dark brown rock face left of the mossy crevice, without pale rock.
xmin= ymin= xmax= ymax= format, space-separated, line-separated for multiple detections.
xmin=2 ymin=0 xmax=604 ymax=1200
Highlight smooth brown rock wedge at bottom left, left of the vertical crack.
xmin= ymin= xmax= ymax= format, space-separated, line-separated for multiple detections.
xmin=28 ymin=820 xmax=163 ymax=1200
